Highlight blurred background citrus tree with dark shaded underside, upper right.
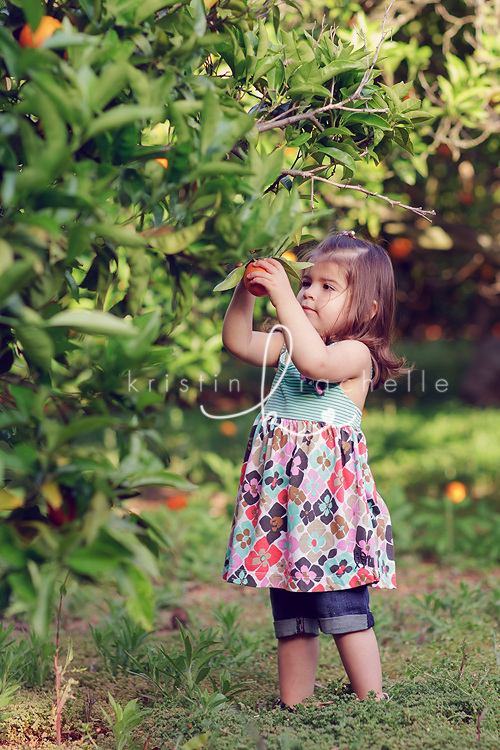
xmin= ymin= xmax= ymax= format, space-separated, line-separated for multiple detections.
xmin=294 ymin=0 xmax=500 ymax=344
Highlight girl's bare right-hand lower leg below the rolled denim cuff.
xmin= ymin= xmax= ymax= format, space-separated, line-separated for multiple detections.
xmin=333 ymin=628 xmax=383 ymax=700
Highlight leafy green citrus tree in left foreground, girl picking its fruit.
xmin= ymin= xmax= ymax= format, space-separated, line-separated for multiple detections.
xmin=0 ymin=0 xmax=430 ymax=633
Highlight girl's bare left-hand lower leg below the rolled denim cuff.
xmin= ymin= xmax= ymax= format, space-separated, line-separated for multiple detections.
xmin=278 ymin=633 xmax=319 ymax=706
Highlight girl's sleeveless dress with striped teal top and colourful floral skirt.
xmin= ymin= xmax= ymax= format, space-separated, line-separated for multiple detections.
xmin=223 ymin=350 xmax=396 ymax=592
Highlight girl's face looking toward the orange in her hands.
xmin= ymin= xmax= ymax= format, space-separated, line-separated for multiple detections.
xmin=297 ymin=259 xmax=351 ymax=339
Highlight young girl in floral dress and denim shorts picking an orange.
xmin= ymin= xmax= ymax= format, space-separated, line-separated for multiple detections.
xmin=223 ymin=232 xmax=403 ymax=706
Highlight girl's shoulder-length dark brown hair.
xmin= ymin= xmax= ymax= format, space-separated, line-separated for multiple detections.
xmin=307 ymin=232 xmax=408 ymax=388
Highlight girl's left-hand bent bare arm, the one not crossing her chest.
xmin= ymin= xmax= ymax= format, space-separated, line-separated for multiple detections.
xmin=222 ymin=282 xmax=284 ymax=367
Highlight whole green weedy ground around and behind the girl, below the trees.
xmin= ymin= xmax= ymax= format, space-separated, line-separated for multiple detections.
xmin=0 ymin=390 xmax=500 ymax=750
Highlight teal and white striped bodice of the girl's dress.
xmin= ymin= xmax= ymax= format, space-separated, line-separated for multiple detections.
xmin=263 ymin=342 xmax=361 ymax=429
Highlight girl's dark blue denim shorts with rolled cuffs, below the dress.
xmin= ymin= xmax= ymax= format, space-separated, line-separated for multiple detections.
xmin=271 ymin=586 xmax=375 ymax=638
